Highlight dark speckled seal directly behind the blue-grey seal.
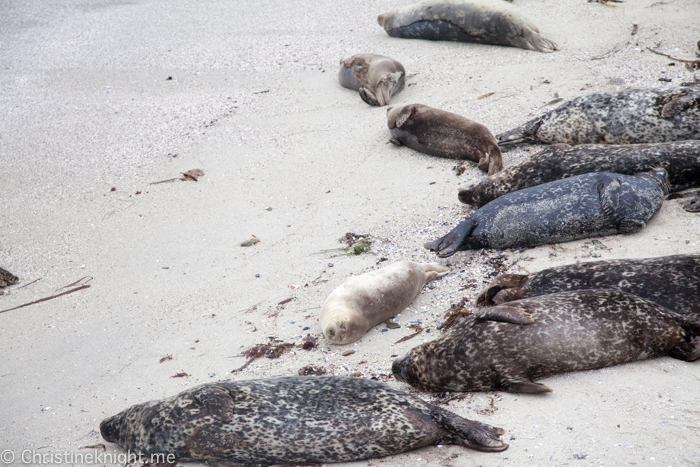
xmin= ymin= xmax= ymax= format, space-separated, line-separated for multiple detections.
xmin=459 ymin=140 xmax=700 ymax=208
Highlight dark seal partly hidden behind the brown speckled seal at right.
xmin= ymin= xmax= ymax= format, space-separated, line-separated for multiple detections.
xmin=476 ymin=254 xmax=700 ymax=316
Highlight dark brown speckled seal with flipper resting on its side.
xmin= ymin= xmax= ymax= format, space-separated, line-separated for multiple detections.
xmin=392 ymin=290 xmax=700 ymax=393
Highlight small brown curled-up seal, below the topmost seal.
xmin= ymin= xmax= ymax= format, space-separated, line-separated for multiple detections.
xmin=338 ymin=54 xmax=406 ymax=107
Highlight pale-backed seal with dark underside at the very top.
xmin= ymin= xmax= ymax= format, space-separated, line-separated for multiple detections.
xmin=377 ymin=0 xmax=559 ymax=52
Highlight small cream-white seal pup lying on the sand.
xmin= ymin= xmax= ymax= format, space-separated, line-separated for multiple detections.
xmin=321 ymin=261 xmax=449 ymax=344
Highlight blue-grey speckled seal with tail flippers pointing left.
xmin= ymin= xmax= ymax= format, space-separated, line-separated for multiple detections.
xmin=425 ymin=170 xmax=667 ymax=258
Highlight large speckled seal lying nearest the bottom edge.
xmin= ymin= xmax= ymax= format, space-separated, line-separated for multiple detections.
xmin=100 ymin=376 xmax=508 ymax=465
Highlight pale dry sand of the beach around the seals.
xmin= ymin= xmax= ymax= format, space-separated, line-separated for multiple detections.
xmin=0 ymin=0 xmax=700 ymax=466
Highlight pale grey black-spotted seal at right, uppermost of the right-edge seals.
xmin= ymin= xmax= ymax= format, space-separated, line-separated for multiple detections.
xmin=496 ymin=87 xmax=700 ymax=146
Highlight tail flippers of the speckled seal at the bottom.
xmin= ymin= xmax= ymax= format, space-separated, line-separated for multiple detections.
xmin=430 ymin=406 xmax=508 ymax=452
